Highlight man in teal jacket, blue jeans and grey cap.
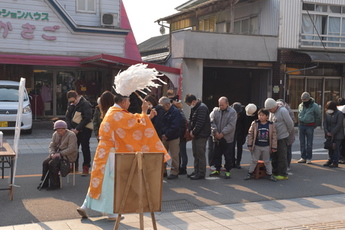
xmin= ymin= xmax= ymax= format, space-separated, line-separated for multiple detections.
xmin=298 ymin=92 xmax=321 ymax=164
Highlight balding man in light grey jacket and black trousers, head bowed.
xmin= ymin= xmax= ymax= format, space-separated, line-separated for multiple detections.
xmin=210 ymin=97 xmax=237 ymax=179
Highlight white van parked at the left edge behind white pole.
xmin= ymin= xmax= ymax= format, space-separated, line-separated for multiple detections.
xmin=0 ymin=80 xmax=32 ymax=134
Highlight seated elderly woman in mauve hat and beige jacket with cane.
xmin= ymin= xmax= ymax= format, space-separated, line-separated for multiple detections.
xmin=38 ymin=120 xmax=78 ymax=190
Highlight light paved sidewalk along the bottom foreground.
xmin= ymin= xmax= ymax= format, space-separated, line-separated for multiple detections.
xmin=0 ymin=194 xmax=345 ymax=230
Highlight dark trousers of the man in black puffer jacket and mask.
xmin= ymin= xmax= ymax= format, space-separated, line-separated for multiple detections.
xmin=192 ymin=137 xmax=208 ymax=177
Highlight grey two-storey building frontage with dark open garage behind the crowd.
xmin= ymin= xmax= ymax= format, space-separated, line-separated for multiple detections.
xmin=158 ymin=0 xmax=345 ymax=120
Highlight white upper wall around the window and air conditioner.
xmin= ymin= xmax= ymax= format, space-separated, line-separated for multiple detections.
xmin=56 ymin=0 xmax=120 ymax=26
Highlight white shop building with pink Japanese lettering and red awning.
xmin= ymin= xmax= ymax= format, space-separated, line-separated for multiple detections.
xmin=0 ymin=0 xmax=179 ymax=119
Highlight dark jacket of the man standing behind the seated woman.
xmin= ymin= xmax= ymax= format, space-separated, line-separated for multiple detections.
xmin=66 ymin=97 xmax=92 ymax=131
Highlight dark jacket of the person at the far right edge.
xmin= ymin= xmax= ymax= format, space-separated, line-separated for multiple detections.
xmin=323 ymin=110 xmax=344 ymax=140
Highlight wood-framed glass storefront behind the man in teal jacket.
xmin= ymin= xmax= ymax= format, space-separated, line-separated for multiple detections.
xmin=285 ymin=52 xmax=345 ymax=124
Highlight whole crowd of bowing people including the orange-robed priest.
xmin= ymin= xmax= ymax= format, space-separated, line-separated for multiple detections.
xmin=40 ymin=90 xmax=345 ymax=220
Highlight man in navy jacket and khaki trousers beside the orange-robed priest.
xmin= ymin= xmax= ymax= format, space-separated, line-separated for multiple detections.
xmin=158 ymin=97 xmax=182 ymax=180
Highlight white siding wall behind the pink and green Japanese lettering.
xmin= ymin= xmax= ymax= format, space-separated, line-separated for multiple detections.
xmin=0 ymin=0 xmax=125 ymax=57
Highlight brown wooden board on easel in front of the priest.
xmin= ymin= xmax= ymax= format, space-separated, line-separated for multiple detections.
xmin=114 ymin=152 xmax=164 ymax=230
